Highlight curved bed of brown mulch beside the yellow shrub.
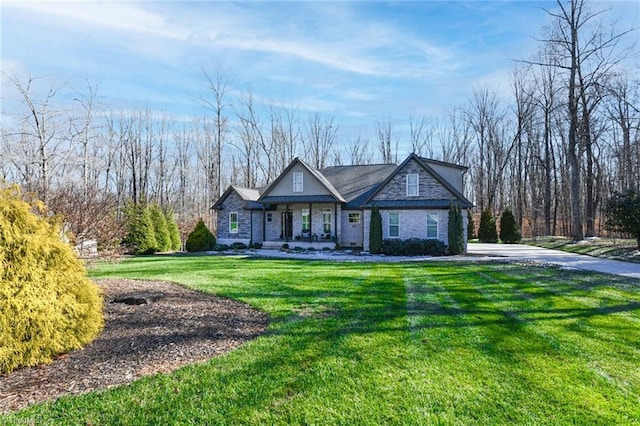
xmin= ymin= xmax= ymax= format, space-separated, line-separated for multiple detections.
xmin=0 ymin=279 xmax=267 ymax=413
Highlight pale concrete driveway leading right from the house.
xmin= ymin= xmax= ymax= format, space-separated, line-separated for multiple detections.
xmin=467 ymin=243 xmax=640 ymax=279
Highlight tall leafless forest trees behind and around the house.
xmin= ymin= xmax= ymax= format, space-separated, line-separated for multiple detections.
xmin=0 ymin=0 xmax=640 ymax=243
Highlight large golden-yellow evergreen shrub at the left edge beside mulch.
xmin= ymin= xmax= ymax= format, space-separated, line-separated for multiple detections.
xmin=0 ymin=184 xmax=104 ymax=374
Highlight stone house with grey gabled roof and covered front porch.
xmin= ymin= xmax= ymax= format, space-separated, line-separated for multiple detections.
xmin=212 ymin=154 xmax=473 ymax=250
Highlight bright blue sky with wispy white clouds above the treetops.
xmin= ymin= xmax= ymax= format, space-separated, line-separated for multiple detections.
xmin=0 ymin=0 xmax=640 ymax=150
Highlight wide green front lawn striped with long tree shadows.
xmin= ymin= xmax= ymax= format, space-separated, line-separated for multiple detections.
xmin=5 ymin=256 xmax=640 ymax=425
